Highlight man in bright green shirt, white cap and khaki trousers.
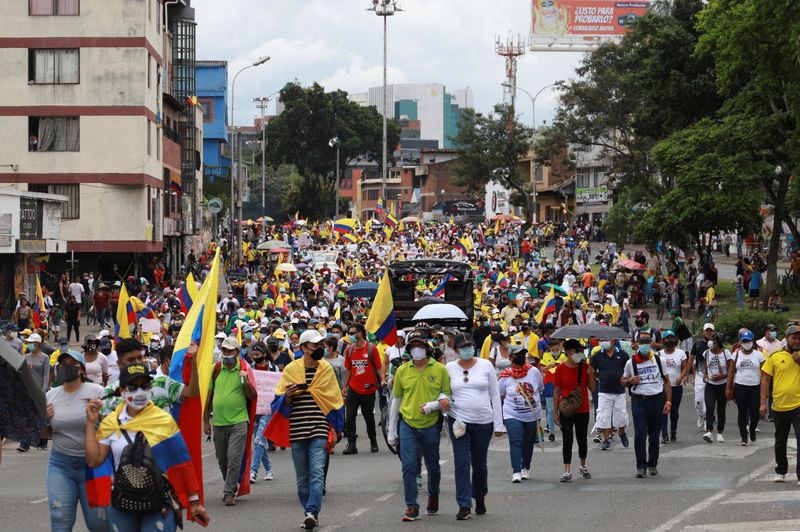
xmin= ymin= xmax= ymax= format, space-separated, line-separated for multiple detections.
xmin=203 ymin=336 xmax=257 ymax=506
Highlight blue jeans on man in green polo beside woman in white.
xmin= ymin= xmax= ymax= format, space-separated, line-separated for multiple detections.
xmin=398 ymin=420 xmax=442 ymax=508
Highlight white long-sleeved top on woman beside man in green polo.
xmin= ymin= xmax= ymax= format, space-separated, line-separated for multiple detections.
xmin=446 ymin=358 xmax=505 ymax=432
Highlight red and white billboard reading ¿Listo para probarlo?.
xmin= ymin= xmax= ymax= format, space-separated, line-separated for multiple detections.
xmin=531 ymin=0 xmax=650 ymax=51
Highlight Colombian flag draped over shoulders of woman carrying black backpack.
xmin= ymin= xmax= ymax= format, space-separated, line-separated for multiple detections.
xmin=86 ymin=402 xmax=200 ymax=508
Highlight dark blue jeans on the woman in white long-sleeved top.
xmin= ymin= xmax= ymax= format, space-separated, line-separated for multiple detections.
xmin=447 ymin=416 xmax=494 ymax=508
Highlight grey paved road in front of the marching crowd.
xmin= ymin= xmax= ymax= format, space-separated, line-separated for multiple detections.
xmin=0 ymin=390 xmax=800 ymax=532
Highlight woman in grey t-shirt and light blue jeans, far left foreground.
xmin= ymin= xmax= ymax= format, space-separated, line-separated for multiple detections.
xmin=45 ymin=350 xmax=108 ymax=532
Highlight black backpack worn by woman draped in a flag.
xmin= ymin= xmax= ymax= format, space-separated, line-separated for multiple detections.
xmin=111 ymin=430 xmax=167 ymax=514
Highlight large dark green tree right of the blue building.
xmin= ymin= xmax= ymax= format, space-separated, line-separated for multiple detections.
xmin=266 ymin=83 xmax=400 ymax=219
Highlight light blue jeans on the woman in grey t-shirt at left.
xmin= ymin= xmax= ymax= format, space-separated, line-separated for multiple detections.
xmin=47 ymin=449 xmax=108 ymax=532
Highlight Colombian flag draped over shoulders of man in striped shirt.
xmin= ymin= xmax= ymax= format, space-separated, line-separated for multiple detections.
xmin=264 ymin=359 xmax=344 ymax=447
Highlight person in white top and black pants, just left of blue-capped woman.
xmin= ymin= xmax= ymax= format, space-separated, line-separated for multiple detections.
xmin=703 ymin=333 xmax=733 ymax=443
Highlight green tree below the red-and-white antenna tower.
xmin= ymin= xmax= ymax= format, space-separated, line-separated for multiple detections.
xmin=453 ymin=105 xmax=534 ymax=228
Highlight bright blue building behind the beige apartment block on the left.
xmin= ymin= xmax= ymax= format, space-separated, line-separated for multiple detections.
xmin=196 ymin=61 xmax=231 ymax=182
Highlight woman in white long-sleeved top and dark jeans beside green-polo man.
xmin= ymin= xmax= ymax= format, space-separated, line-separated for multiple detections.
xmin=447 ymin=334 xmax=505 ymax=521
